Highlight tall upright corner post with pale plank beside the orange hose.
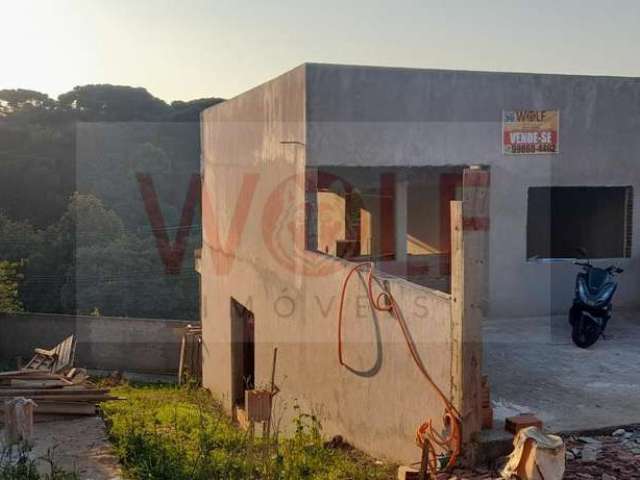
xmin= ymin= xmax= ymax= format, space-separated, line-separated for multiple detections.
xmin=451 ymin=168 xmax=489 ymax=454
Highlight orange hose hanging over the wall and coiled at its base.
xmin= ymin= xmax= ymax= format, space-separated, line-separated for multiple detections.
xmin=338 ymin=262 xmax=462 ymax=472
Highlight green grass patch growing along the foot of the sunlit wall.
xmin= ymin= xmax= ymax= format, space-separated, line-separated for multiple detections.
xmin=102 ymin=385 xmax=393 ymax=480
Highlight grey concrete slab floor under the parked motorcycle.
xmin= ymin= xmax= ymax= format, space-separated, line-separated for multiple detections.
xmin=484 ymin=312 xmax=640 ymax=432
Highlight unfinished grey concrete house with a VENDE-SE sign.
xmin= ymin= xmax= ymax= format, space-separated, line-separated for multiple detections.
xmin=198 ymin=64 xmax=640 ymax=462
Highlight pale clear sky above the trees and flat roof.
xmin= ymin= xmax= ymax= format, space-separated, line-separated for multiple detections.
xmin=0 ymin=0 xmax=640 ymax=101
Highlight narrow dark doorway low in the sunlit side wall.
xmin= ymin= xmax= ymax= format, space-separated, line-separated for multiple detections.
xmin=231 ymin=298 xmax=255 ymax=406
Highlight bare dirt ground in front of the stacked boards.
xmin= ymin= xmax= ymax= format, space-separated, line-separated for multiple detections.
xmin=7 ymin=417 xmax=123 ymax=480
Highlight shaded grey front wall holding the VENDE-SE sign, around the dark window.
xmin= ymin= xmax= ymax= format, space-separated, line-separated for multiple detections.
xmin=306 ymin=64 xmax=640 ymax=316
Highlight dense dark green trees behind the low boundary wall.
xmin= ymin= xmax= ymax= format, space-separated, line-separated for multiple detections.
xmin=0 ymin=85 xmax=222 ymax=319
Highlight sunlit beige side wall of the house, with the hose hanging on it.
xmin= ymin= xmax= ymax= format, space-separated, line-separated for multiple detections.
xmin=200 ymin=67 xmax=460 ymax=462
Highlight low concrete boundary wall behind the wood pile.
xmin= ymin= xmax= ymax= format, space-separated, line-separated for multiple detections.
xmin=0 ymin=313 xmax=188 ymax=374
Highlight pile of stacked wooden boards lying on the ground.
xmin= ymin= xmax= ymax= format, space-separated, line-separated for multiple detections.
xmin=0 ymin=369 xmax=116 ymax=421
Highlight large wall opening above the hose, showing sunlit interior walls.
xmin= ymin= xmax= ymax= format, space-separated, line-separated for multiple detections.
xmin=306 ymin=166 xmax=464 ymax=292
